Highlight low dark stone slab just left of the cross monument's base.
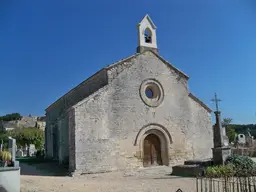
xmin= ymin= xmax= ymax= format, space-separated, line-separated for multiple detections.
xmin=172 ymin=165 xmax=204 ymax=177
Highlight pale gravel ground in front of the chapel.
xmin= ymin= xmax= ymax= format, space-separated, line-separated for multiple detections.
xmin=21 ymin=166 xmax=196 ymax=192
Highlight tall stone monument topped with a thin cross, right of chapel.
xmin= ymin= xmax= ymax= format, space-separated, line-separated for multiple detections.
xmin=212 ymin=93 xmax=231 ymax=165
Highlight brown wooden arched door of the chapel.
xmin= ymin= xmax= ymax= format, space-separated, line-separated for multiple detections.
xmin=143 ymin=134 xmax=163 ymax=167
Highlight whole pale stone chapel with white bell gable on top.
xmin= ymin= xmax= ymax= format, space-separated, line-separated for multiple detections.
xmin=45 ymin=15 xmax=213 ymax=173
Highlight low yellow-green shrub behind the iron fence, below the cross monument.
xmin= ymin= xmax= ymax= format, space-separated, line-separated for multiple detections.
xmin=205 ymin=164 xmax=235 ymax=177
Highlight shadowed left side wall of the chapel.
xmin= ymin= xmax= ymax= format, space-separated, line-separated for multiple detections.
xmin=45 ymin=69 xmax=108 ymax=162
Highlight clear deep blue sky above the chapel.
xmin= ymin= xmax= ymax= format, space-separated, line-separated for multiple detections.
xmin=0 ymin=0 xmax=256 ymax=123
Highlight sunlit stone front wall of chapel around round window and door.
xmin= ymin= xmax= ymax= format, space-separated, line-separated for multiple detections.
xmin=69 ymin=52 xmax=212 ymax=172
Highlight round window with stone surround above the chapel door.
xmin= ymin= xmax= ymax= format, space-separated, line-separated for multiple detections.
xmin=140 ymin=79 xmax=164 ymax=107
